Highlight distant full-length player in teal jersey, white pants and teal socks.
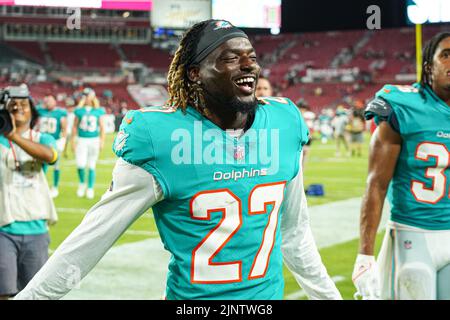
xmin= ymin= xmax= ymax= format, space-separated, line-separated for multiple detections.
xmin=72 ymin=88 xmax=106 ymax=199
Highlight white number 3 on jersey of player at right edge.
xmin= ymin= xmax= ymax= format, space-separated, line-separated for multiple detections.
xmin=411 ymin=142 xmax=450 ymax=204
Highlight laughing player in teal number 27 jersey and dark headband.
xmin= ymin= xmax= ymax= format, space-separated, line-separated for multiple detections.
xmin=17 ymin=20 xmax=341 ymax=299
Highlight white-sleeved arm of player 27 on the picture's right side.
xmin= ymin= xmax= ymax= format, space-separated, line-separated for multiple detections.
xmin=281 ymin=152 xmax=342 ymax=300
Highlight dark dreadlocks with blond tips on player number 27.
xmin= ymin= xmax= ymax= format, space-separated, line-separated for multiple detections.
xmin=166 ymin=20 xmax=212 ymax=116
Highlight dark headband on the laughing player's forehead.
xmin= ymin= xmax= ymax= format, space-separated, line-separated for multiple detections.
xmin=189 ymin=20 xmax=248 ymax=64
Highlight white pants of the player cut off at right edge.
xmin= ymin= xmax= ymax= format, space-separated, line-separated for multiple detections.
xmin=377 ymin=221 xmax=450 ymax=300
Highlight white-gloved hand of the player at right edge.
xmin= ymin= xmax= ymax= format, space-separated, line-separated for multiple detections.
xmin=352 ymin=254 xmax=381 ymax=300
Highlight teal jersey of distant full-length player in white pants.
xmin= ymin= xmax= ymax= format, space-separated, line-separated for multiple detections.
xmin=74 ymin=106 xmax=106 ymax=138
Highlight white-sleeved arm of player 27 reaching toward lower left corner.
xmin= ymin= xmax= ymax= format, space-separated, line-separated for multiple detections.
xmin=15 ymin=159 xmax=163 ymax=299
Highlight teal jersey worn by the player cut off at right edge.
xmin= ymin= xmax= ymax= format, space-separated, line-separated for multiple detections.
xmin=376 ymin=84 xmax=450 ymax=230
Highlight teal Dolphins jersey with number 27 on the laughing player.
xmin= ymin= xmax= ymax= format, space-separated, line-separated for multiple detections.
xmin=113 ymin=98 xmax=309 ymax=299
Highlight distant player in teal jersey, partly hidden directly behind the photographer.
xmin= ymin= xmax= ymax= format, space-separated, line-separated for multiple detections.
xmin=37 ymin=95 xmax=67 ymax=198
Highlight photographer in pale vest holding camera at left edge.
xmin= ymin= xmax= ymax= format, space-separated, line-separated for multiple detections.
xmin=0 ymin=86 xmax=58 ymax=299
